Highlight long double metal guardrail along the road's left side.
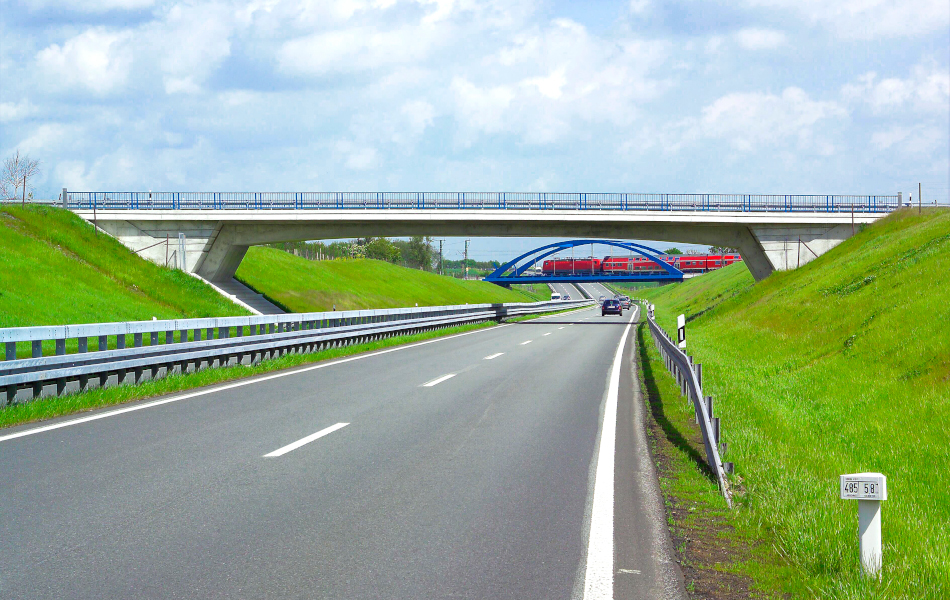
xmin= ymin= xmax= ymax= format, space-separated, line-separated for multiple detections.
xmin=0 ymin=300 xmax=591 ymax=406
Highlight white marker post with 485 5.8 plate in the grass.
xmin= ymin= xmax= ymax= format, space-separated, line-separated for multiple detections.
xmin=841 ymin=473 xmax=887 ymax=577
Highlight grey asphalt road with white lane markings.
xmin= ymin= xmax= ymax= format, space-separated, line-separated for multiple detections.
xmin=0 ymin=309 xmax=683 ymax=599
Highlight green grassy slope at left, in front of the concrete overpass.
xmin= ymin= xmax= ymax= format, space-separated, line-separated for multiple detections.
xmin=0 ymin=206 xmax=247 ymax=327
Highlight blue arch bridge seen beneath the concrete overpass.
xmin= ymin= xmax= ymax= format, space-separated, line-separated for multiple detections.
xmin=485 ymin=239 xmax=683 ymax=287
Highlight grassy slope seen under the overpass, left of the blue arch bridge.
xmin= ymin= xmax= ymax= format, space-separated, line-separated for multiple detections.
xmin=237 ymin=247 xmax=550 ymax=312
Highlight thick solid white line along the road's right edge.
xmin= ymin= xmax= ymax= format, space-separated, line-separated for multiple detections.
xmin=584 ymin=308 xmax=633 ymax=600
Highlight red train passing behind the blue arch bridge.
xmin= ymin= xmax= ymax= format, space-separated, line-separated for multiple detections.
xmin=541 ymin=254 xmax=742 ymax=275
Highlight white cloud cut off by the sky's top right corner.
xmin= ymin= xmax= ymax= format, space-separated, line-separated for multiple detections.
xmin=746 ymin=0 xmax=950 ymax=39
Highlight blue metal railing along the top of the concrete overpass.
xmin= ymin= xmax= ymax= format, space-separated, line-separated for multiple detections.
xmin=65 ymin=192 xmax=900 ymax=213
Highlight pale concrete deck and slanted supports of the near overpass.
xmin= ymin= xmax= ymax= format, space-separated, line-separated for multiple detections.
xmin=83 ymin=210 xmax=886 ymax=282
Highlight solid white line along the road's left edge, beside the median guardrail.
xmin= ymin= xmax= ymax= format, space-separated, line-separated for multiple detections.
xmin=0 ymin=306 xmax=590 ymax=442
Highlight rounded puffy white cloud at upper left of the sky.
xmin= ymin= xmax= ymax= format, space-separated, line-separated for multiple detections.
xmin=36 ymin=27 xmax=132 ymax=95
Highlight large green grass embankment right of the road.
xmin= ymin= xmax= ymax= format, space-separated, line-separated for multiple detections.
xmin=638 ymin=210 xmax=950 ymax=599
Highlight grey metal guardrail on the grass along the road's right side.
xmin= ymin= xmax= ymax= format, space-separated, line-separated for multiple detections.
xmin=646 ymin=305 xmax=732 ymax=508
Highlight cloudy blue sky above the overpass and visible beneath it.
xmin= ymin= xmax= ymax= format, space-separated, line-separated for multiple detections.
xmin=0 ymin=0 xmax=950 ymax=260
